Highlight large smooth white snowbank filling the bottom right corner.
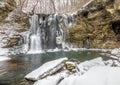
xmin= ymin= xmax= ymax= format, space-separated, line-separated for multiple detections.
xmin=59 ymin=66 xmax=120 ymax=85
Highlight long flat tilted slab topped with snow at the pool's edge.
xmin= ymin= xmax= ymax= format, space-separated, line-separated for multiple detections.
xmin=25 ymin=57 xmax=68 ymax=80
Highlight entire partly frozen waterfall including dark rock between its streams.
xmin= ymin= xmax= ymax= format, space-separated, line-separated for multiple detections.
xmin=28 ymin=14 xmax=74 ymax=52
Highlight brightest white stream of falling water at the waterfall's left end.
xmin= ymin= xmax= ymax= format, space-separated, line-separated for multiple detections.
xmin=29 ymin=15 xmax=42 ymax=52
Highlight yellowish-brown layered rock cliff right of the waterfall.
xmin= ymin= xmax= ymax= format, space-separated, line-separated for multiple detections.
xmin=67 ymin=1 xmax=120 ymax=48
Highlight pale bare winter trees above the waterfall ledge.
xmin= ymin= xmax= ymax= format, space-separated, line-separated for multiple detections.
xmin=16 ymin=0 xmax=90 ymax=14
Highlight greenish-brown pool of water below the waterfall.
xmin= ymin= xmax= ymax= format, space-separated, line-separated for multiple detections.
xmin=0 ymin=51 xmax=109 ymax=85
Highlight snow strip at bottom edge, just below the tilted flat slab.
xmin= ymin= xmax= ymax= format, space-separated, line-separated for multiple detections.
xmin=34 ymin=71 xmax=68 ymax=85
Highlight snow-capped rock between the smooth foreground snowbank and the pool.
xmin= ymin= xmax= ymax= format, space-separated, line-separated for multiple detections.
xmin=78 ymin=57 xmax=105 ymax=74
